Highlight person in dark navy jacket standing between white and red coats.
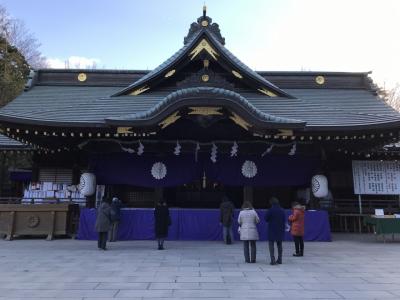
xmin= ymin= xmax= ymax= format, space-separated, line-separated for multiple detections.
xmin=265 ymin=197 xmax=286 ymax=265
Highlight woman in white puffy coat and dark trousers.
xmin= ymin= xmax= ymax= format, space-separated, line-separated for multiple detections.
xmin=238 ymin=201 xmax=260 ymax=263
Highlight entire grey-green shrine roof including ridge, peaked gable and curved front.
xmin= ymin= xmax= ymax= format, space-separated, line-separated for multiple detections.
xmin=0 ymin=10 xmax=400 ymax=132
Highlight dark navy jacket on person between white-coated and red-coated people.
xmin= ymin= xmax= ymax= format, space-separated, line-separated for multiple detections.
xmin=265 ymin=204 xmax=286 ymax=241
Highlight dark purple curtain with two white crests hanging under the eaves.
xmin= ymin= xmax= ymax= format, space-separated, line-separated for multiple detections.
xmin=90 ymin=153 xmax=319 ymax=187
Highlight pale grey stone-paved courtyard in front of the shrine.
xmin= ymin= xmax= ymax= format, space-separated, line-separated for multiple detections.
xmin=0 ymin=235 xmax=400 ymax=300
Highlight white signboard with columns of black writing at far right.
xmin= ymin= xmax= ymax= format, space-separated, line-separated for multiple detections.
xmin=353 ymin=160 xmax=400 ymax=195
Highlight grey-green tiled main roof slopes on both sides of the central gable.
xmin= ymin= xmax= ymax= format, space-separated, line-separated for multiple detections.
xmin=0 ymin=86 xmax=400 ymax=130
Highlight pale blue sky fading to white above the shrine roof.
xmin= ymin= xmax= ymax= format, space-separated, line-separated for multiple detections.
xmin=0 ymin=0 xmax=400 ymax=86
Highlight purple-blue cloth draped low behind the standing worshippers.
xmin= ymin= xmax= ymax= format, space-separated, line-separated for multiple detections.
xmin=78 ymin=209 xmax=331 ymax=242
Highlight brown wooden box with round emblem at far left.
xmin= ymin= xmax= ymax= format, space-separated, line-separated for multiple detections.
xmin=0 ymin=203 xmax=79 ymax=240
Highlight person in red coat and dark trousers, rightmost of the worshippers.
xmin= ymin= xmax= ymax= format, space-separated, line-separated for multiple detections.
xmin=289 ymin=202 xmax=305 ymax=256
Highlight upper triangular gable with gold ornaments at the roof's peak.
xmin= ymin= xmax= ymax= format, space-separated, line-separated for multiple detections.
xmin=113 ymin=11 xmax=294 ymax=98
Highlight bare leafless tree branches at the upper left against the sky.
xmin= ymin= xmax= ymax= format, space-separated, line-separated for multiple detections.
xmin=0 ymin=5 xmax=48 ymax=69
